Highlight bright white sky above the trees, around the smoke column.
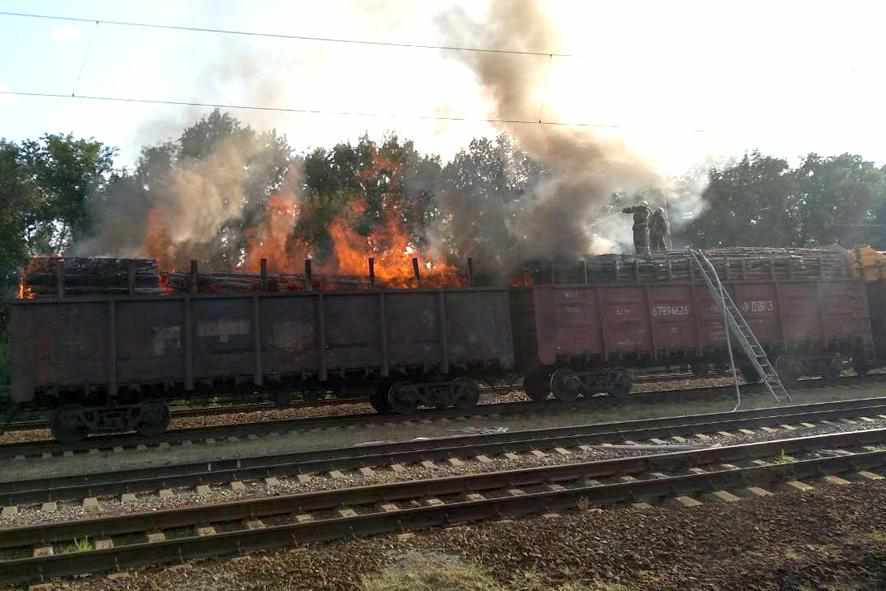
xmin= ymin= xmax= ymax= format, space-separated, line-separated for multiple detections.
xmin=0 ymin=0 xmax=886 ymax=174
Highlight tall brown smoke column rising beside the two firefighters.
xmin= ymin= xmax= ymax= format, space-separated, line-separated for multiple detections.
xmin=441 ymin=0 xmax=660 ymax=257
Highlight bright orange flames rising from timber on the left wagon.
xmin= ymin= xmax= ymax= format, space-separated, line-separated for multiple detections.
xmin=130 ymin=154 xmax=466 ymax=290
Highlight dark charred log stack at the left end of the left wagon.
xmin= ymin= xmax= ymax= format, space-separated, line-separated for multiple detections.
xmin=21 ymin=257 xmax=163 ymax=297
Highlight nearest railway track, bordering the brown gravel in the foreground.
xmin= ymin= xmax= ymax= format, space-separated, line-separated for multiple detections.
xmin=0 ymin=429 xmax=886 ymax=583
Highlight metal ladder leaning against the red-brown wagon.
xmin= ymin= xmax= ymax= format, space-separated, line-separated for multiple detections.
xmin=689 ymin=250 xmax=791 ymax=402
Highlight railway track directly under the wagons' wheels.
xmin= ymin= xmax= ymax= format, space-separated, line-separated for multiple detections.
xmin=0 ymin=375 xmax=886 ymax=460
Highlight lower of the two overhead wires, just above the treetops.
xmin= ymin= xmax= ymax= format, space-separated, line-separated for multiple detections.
xmin=0 ymin=90 xmax=688 ymax=133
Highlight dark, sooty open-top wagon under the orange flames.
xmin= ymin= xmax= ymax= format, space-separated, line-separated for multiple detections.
xmin=10 ymin=288 xmax=513 ymax=440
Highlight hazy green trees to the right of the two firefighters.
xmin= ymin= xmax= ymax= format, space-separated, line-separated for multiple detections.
xmin=684 ymin=152 xmax=886 ymax=248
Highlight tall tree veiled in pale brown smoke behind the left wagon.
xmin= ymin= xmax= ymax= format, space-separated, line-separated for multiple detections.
xmin=83 ymin=110 xmax=291 ymax=270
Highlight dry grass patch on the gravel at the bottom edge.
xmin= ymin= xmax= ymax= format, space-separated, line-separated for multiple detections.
xmin=360 ymin=556 xmax=629 ymax=591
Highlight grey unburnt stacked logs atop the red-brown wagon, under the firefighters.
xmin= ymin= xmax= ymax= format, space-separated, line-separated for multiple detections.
xmin=515 ymin=247 xmax=854 ymax=285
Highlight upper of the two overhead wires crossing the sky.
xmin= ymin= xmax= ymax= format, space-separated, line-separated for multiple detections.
xmin=0 ymin=10 xmax=574 ymax=57
